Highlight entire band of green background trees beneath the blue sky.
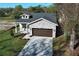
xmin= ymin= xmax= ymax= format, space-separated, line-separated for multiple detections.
xmin=0 ymin=4 xmax=56 ymax=19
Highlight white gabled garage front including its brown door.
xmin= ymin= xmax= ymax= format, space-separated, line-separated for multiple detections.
xmin=29 ymin=19 xmax=56 ymax=38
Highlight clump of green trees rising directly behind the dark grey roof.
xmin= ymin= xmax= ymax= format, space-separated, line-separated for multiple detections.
xmin=27 ymin=5 xmax=57 ymax=13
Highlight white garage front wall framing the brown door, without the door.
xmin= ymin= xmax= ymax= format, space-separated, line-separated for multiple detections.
xmin=29 ymin=20 xmax=56 ymax=38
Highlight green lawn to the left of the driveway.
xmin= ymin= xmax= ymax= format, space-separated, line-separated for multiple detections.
xmin=0 ymin=30 xmax=27 ymax=56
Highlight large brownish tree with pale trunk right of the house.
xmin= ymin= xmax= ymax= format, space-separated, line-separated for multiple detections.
xmin=56 ymin=3 xmax=79 ymax=55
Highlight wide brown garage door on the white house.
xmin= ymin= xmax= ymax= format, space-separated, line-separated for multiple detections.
xmin=32 ymin=28 xmax=52 ymax=37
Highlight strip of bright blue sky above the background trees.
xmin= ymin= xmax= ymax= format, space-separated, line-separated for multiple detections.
xmin=0 ymin=3 xmax=51 ymax=8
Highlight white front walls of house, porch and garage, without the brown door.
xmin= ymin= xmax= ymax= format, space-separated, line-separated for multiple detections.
xmin=19 ymin=19 xmax=57 ymax=38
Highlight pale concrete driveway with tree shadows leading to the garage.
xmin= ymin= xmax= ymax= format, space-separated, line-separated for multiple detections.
xmin=18 ymin=36 xmax=53 ymax=56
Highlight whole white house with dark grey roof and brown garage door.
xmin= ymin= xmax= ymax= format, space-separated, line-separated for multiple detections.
xmin=15 ymin=12 xmax=58 ymax=38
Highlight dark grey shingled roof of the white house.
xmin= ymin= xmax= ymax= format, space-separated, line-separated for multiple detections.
xmin=16 ymin=13 xmax=57 ymax=24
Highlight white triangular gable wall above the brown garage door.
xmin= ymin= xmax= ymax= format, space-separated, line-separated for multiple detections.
xmin=30 ymin=20 xmax=56 ymax=29
